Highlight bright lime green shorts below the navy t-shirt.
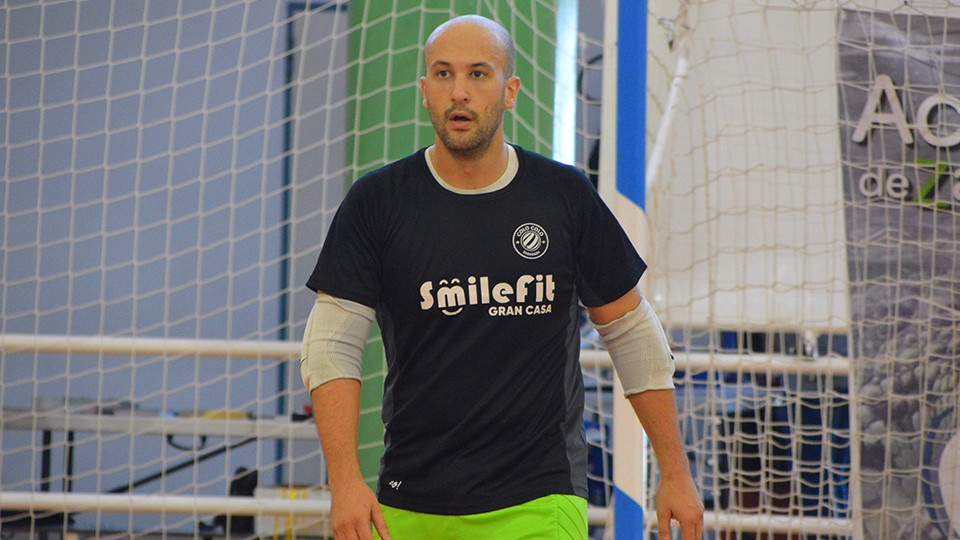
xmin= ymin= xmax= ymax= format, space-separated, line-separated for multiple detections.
xmin=373 ymin=495 xmax=587 ymax=540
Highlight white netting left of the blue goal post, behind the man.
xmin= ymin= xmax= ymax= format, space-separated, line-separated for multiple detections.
xmin=0 ymin=0 xmax=605 ymax=538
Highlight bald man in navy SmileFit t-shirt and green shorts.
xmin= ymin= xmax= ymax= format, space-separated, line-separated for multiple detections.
xmin=301 ymin=15 xmax=703 ymax=540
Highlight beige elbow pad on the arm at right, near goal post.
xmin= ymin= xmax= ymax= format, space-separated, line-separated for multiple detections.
xmin=597 ymin=298 xmax=675 ymax=396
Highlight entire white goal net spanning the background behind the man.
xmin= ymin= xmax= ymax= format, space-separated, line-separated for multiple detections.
xmin=0 ymin=0 xmax=960 ymax=540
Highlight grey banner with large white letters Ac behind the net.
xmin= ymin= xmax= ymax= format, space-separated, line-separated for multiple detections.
xmin=838 ymin=10 xmax=960 ymax=539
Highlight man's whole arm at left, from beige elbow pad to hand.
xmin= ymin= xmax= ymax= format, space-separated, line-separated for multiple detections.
xmin=300 ymin=292 xmax=390 ymax=540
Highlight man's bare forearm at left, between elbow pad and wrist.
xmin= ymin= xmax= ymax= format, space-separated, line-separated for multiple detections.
xmin=310 ymin=379 xmax=363 ymax=488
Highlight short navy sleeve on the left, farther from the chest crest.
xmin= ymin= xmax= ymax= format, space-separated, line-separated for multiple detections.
xmin=307 ymin=179 xmax=382 ymax=308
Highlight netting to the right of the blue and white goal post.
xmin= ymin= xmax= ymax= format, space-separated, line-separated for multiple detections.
xmin=648 ymin=0 xmax=960 ymax=538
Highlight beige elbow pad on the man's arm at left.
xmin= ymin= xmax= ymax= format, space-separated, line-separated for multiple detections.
xmin=300 ymin=293 xmax=374 ymax=392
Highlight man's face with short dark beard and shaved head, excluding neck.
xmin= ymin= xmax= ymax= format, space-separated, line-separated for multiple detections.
xmin=420 ymin=24 xmax=520 ymax=156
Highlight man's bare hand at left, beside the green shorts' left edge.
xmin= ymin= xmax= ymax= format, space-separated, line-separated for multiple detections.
xmin=330 ymin=480 xmax=390 ymax=540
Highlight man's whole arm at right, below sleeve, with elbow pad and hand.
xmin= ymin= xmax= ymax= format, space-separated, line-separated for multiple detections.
xmin=587 ymin=289 xmax=703 ymax=540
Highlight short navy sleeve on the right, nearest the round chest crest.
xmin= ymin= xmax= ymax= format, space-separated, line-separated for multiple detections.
xmin=577 ymin=179 xmax=647 ymax=307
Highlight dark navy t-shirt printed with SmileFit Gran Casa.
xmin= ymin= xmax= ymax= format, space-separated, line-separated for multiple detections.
xmin=307 ymin=147 xmax=646 ymax=515
